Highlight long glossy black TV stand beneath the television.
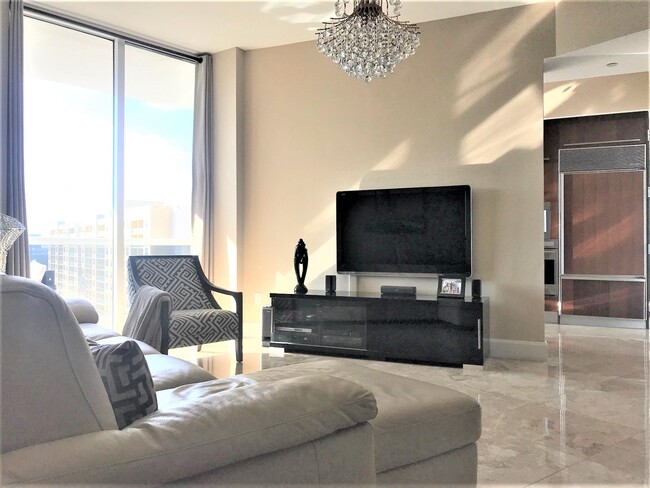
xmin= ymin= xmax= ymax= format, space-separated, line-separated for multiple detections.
xmin=271 ymin=291 xmax=489 ymax=366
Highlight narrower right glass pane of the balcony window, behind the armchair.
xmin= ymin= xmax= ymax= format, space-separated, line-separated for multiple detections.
xmin=124 ymin=45 xmax=194 ymax=254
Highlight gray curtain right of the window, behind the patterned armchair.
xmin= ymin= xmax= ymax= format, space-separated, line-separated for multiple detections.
xmin=192 ymin=54 xmax=214 ymax=278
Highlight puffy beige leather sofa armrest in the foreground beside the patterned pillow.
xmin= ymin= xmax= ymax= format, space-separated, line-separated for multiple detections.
xmin=2 ymin=375 xmax=377 ymax=485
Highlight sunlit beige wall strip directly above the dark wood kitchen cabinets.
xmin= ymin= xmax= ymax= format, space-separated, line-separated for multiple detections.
xmin=544 ymin=72 xmax=650 ymax=118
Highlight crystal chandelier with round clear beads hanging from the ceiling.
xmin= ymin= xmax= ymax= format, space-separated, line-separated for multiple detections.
xmin=316 ymin=0 xmax=420 ymax=82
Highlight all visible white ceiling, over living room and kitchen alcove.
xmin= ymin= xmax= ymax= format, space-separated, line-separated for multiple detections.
xmin=29 ymin=0 xmax=649 ymax=81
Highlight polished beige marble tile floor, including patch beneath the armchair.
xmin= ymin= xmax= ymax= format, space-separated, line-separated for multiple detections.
xmin=174 ymin=325 xmax=650 ymax=487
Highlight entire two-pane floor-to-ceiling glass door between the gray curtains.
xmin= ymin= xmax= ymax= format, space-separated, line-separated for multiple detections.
xmin=24 ymin=17 xmax=194 ymax=330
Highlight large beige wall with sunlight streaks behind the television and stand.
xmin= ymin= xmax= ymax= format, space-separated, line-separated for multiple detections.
xmin=238 ymin=4 xmax=555 ymax=343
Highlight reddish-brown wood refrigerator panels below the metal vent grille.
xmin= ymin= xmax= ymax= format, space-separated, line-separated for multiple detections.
xmin=562 ymin=171 xmax=645 ymax=320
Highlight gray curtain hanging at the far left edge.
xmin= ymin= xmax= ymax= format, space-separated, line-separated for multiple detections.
xmin=2 ymin=0 xmax=29 ymax=276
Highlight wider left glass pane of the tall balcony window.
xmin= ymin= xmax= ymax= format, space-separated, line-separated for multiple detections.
xmin=24 ymin=18 xmax=113 ymax=320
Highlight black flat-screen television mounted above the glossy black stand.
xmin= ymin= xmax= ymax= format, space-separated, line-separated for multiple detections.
xmin=336 ymin=185 xmax=472 ymax=276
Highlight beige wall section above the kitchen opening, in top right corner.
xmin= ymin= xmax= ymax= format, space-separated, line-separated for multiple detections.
xmin=556 ymin=0 xmax=650 ymax=55
